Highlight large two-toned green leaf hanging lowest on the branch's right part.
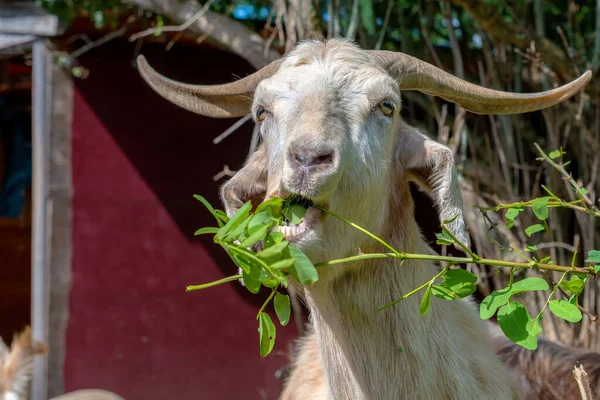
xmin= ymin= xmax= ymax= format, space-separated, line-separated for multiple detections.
xmin=498 ymin=302 xmax=541 ymax=350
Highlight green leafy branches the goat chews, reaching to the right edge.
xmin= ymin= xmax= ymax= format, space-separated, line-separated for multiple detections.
xmin=187 ymin=145 xmax=600 ymax=357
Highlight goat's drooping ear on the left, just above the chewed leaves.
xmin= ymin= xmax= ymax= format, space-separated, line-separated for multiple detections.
xmin=221 ymin=146 xmax=268 ymax=216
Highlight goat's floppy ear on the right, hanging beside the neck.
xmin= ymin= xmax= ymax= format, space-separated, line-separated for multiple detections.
xmin=396 ymin=124 xmax=467 ymax=244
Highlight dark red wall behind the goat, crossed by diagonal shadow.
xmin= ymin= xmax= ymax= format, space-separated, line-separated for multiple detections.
xmin=65 ymin=44 xmax=296 ymax=400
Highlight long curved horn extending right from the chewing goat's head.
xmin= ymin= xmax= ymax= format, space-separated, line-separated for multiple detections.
xmin=371 ymin=51 xmax=592 ymax=114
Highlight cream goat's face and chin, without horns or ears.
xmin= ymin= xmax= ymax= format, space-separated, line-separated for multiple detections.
xmin=244 ymin=43 xmax=400 ymax=260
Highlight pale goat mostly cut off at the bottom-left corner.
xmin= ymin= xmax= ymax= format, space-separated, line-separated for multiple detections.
xmin=0 ymin=326 xmax=124 ymax=400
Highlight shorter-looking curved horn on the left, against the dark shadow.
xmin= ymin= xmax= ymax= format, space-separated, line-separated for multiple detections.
xmin=137 ymin=56 xmax=281 ymax=118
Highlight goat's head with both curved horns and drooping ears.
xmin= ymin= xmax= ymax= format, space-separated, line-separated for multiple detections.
xmin=138 ymin=40 xmax=591 ymax=272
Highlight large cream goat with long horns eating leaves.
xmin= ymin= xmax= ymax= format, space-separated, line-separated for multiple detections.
xmin=138 ymin=39 xmax=591 ymax=400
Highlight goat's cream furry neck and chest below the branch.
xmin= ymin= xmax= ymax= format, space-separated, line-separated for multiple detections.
xmin=307 ymin=211 xmax=513 ymax=400
